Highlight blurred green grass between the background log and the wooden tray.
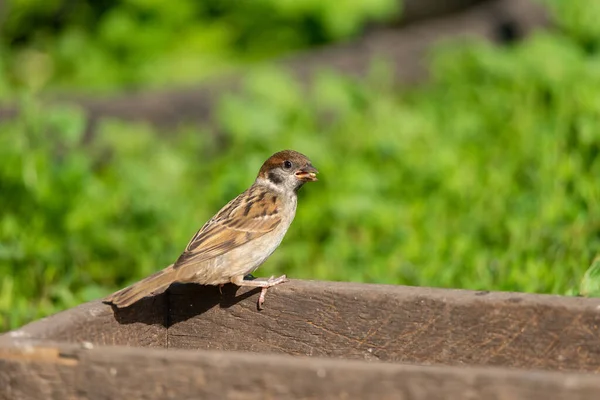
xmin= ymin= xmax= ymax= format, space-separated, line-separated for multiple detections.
xmin=0 ymin=1 xmax=600 ymax=329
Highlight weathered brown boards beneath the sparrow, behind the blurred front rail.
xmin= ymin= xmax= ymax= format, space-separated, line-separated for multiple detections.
xmin=0 ymin=280 xmax=600 ymax=372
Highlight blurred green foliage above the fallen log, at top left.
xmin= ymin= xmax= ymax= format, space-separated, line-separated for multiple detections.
xmin=0 ymin=0 xmax=397 ymax=91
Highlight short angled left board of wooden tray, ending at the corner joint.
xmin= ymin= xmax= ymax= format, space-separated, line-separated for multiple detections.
xmin=0 ymin=297 xmax=168 ymax=347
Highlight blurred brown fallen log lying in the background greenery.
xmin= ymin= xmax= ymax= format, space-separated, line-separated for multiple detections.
xmin=0 ymin=0 xmax=548 ymax=134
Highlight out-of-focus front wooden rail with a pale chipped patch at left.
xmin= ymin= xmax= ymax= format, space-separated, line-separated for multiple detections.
xmin=0 ymin=344 xmax=600 ymax=400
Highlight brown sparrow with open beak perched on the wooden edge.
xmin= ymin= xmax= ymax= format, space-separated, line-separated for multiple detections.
xmin=103 ymin=150 xmax=318 ymax=310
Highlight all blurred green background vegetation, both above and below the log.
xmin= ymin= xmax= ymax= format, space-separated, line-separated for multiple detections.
xmin=0 ymin=0 xmax=600 ymax=330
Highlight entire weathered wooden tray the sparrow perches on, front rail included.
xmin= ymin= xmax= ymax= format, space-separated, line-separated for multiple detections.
xmin=0 ymin=280 xmax=600 ymax=400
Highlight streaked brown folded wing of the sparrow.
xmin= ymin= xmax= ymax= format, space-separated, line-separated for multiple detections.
xmin=173 ymin=186 xmax=282 ymax=269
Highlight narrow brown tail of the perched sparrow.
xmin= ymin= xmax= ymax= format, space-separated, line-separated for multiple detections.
xmin=102 ymin=264 xmax=178 ymax=308
